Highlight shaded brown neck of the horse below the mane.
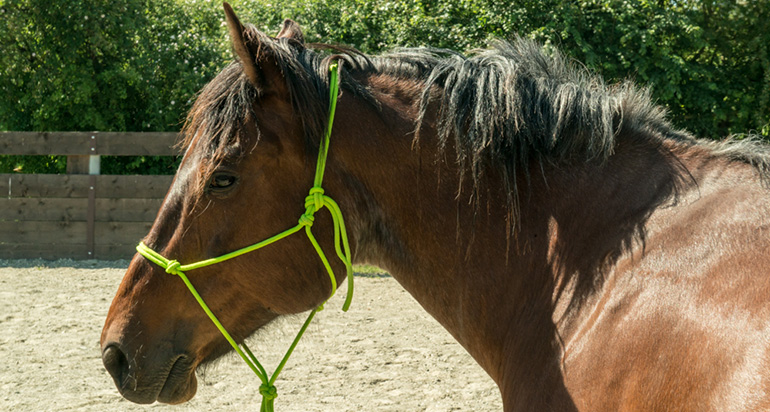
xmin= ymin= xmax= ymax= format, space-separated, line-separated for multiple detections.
xmin=331 ymin=77 xmax=688 ymax=383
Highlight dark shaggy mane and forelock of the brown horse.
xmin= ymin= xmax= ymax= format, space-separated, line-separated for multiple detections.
xmin=182 ymin=25 xmax=770 ymax=212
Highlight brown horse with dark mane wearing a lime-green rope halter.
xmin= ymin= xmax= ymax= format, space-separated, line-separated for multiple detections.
xmin=101 ymin=6 xmax=770 ymax=412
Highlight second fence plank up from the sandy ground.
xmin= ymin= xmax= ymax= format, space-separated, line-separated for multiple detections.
xmin=0 ymin=221 xmax=152 ymax=245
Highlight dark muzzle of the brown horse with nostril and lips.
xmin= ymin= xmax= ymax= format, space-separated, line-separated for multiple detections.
xmin=102 ymin=343 xmax=198 ymax=404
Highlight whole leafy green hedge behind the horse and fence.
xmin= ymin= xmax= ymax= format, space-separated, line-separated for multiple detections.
xmin=0 ymin=0 xmax=770 ymax=173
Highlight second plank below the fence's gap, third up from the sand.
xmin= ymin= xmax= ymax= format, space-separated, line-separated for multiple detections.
xmin=0 ymin=197 xmax=163 ymax=222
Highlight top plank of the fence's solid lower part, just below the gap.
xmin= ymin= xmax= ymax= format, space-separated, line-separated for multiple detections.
xmin=0 ymin=173 xmax=174 ymax=199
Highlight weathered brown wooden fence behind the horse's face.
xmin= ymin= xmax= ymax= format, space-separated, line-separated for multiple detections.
xmin=0 ymin=132 xmax=176 ymax=259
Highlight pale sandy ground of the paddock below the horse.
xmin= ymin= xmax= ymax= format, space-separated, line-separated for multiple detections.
xmin=0 ymin=260 xmax=502 ymax=412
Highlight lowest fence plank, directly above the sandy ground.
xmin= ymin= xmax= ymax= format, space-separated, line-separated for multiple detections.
xmin=0 ymin=243 xmax=136 ymax=260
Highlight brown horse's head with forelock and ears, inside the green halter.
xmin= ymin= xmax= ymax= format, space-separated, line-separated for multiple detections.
xmin=101 ymin=3 xmax=344 ymax=403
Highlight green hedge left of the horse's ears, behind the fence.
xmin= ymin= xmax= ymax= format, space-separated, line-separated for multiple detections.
xmin=0 ymin=0 xmax=228 ymax=173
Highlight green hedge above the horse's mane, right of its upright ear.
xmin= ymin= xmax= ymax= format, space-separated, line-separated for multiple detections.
xmin=238 ymin=0 xmax=770 ymax=138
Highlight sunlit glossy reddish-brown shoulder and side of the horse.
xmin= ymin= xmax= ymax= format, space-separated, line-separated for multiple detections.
xmin=563 ymin=165 xmax=770 ymax=411
